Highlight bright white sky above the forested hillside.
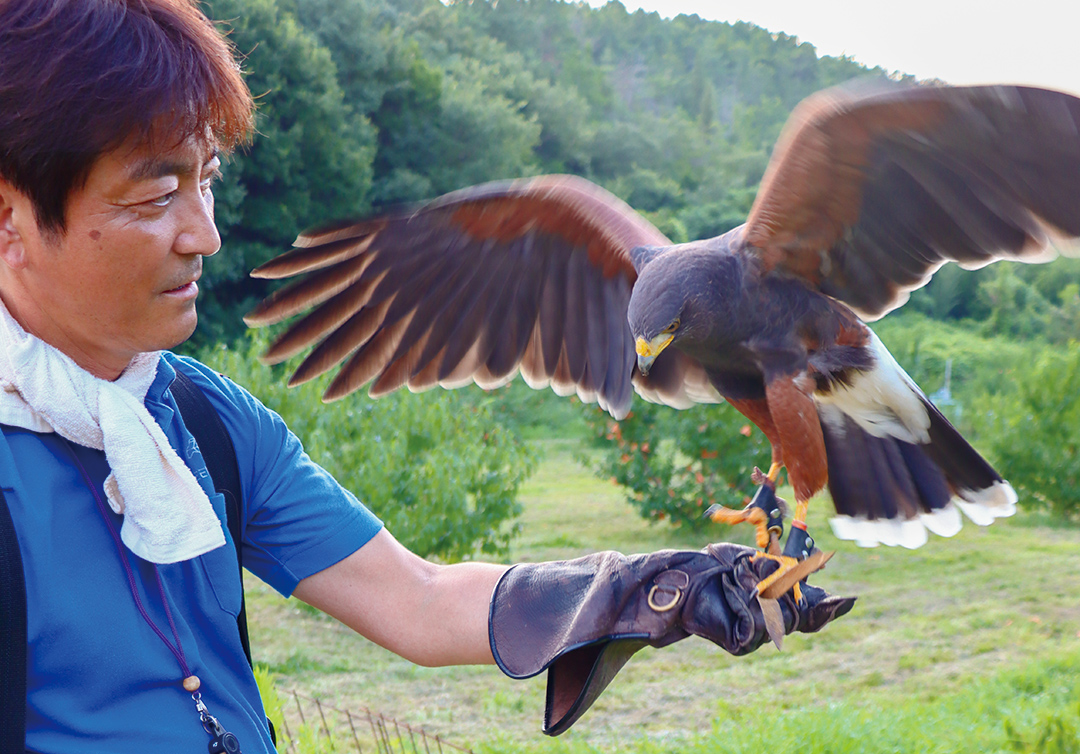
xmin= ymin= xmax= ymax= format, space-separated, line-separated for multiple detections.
xmin=588 ymin=0 xmax=1080 ymax=94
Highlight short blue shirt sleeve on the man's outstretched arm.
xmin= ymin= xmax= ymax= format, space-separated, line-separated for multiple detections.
xmin=171 ymin=354 xmax=382 ymax=596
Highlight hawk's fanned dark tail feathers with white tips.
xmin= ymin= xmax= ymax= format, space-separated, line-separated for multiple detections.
xmin=819 ymin=367 xmax=1016 ymax=548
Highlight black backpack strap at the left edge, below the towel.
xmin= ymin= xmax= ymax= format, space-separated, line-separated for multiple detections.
xmin=0 ymin=481 xmax=27 ymax=752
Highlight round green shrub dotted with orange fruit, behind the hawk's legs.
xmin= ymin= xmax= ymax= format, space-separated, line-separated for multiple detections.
xmin=591 ymin=400 xmax=770 ymax=530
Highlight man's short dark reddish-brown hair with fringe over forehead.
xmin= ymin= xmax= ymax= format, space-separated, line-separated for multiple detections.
xmin=0 ymin=0 xmax=253 ymax=232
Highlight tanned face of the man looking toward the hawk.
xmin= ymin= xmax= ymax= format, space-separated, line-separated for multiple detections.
xmin=0 ymin=138 xmax=220 ymax=379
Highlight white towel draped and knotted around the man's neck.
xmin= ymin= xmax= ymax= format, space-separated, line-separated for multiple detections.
xmin=0 ymin=301 xmax=225 ymax=563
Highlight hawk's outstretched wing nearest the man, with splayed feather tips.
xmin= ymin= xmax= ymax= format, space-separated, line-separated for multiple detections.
xmin=245 ymin=176 xmax=717 ymax=417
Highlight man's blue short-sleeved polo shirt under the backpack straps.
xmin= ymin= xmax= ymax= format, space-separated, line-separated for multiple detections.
xmin=0 ymin=353 xmax=381 ymax=754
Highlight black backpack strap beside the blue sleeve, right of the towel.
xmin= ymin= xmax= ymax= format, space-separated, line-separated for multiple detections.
xmin=170 ymin=369 xmax=253 ymax=665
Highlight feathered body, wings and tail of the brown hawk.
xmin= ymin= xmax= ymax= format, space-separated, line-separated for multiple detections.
xmin=246 ymin=85 xmax=1080 ymax=546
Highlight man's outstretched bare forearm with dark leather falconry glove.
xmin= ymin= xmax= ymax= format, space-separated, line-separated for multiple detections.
xmin=296 ymin=530 xmax=854 ymax=736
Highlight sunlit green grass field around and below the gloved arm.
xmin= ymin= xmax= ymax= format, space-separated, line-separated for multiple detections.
xmin=247 ymin=441 xmax=1080 ymax=754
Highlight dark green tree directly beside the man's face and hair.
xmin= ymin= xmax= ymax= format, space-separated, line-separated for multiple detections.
xmin=194 ymin=0 xmax=375 ymax=346
